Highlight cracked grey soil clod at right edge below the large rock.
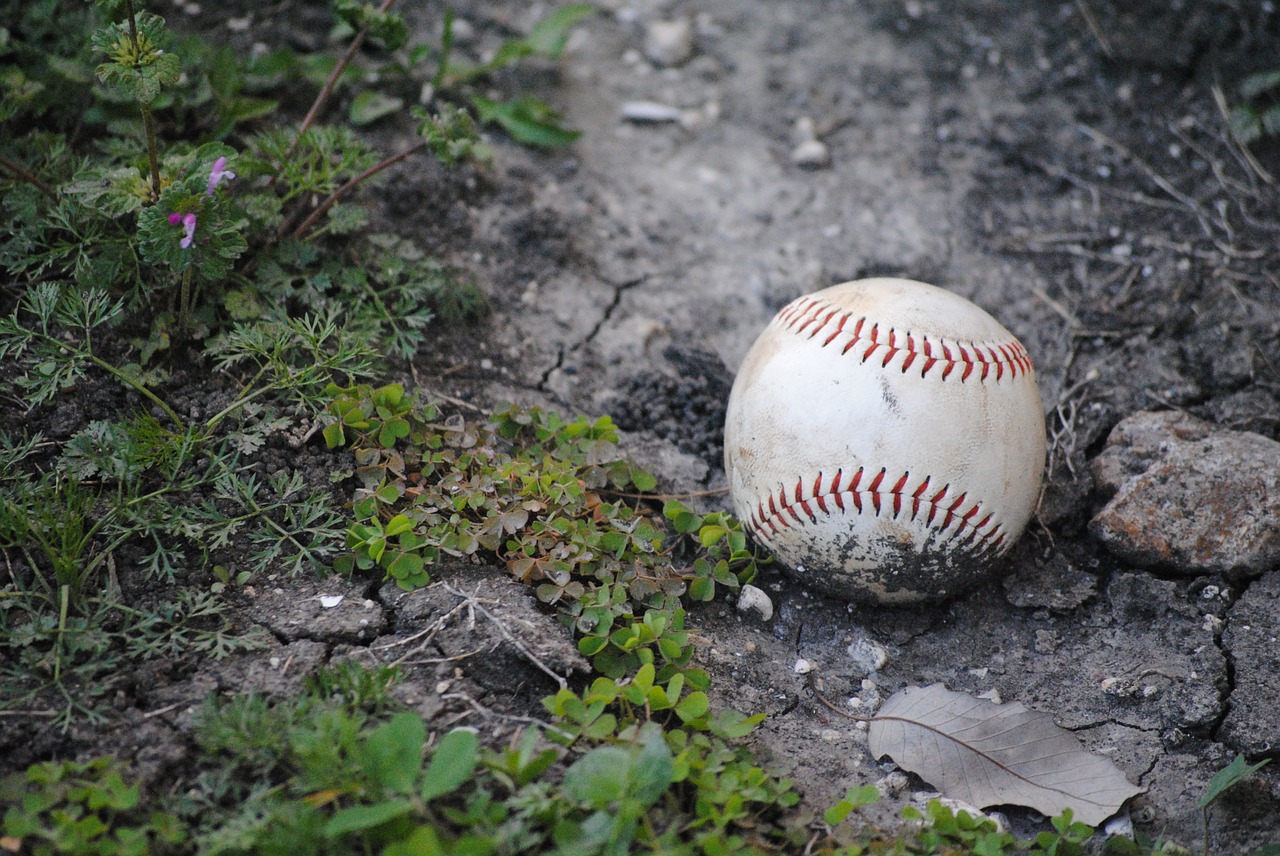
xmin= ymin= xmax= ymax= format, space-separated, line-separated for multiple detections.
xmin=1220 ymin=573 xmax=1280 ymax=756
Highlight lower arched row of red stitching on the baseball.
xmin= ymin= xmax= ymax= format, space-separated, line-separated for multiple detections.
xmin=748 ymin=467 xmax=1006 ymax=555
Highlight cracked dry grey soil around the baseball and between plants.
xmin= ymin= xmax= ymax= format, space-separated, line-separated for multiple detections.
xmin=0 ymin=0 xmax=1280 ymax=853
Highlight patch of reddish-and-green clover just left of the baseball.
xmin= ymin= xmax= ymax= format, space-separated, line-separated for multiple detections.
xmin=325 ymin=384 xmax=756 ymax=683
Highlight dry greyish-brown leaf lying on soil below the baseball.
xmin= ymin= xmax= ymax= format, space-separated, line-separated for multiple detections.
xmin=868 ymin=683 xmax=1143 ymax=827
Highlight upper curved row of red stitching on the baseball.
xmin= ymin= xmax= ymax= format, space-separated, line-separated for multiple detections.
xmin=778 ymin=297 xmax=1033 ymax=384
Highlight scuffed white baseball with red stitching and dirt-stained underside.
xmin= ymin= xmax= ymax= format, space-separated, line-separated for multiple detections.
xmin=724 ymin=279 xmax=1044 ymax=604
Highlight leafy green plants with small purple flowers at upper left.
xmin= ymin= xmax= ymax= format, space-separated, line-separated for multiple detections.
xmin=0 ymin=0 xmax=570 ymax=353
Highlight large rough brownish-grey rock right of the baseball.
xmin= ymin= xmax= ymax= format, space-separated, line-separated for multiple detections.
xmin=1089 ymin=412 xmax=1280 ymax=576
